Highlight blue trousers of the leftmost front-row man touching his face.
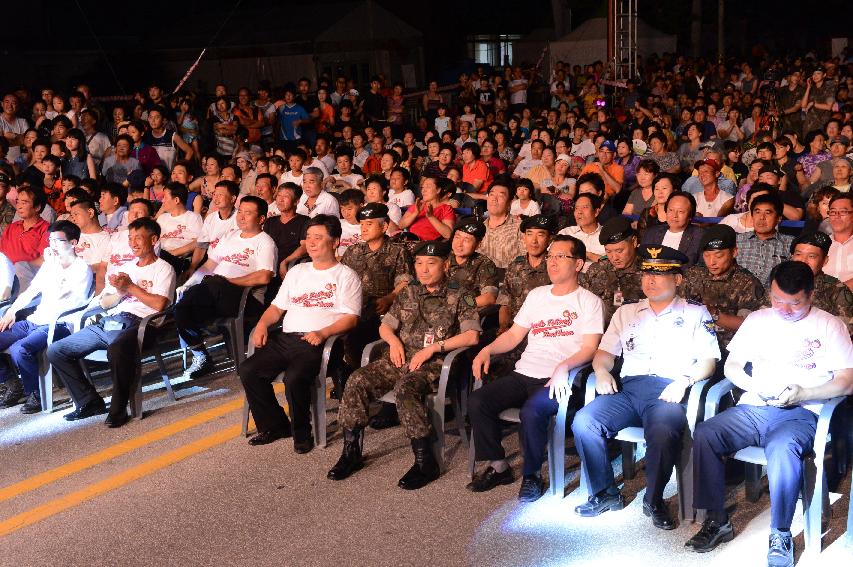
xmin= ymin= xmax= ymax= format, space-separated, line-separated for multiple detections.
xmin=0 ymin=320 xmax=70 ymax=396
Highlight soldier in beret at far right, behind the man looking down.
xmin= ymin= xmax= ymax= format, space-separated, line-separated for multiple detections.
xmin=791 ymin=232 xmax=853 ymax=336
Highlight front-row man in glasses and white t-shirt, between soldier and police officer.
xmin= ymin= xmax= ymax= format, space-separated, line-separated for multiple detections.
xmin=468 ymin=235 xmax=604 ymax=502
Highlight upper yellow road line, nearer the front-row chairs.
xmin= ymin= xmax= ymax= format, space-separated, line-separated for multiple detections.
xmin=0 ymin=384 xmax=284 ymax=502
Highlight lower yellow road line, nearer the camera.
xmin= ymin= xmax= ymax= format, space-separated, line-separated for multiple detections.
xmin=0 ymin=425 xmax=240 ymax=537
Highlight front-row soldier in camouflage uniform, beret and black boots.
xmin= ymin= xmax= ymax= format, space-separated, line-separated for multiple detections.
xmin=328 ymin=241 xmax=480 ymax=490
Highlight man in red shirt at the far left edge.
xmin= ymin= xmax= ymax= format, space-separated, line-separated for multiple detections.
xmin=0 ymin=186 xmax=48 ymax=293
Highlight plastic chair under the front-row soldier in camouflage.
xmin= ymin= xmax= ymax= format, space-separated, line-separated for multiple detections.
xmin=361 ymin=339 xmax=470 ymax=472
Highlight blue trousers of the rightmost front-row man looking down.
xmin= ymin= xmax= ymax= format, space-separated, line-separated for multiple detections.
xmin=693 ymin=405 xmax=820 ymax=530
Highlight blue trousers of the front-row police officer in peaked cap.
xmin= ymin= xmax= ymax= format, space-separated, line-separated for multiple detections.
xmin=572 ymin=376 xmax=687 ymax=504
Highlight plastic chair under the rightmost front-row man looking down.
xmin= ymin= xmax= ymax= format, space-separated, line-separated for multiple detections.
xmin=705 ymin=379 xmax=853 ymax=554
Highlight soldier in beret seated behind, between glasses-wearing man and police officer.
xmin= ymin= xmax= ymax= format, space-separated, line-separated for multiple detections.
xmin=580 ymin=217 xmax=645 ymax=325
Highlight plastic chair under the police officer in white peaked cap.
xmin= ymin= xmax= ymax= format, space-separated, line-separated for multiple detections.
xmin=580 ymin=372 xmax=709 ymax=520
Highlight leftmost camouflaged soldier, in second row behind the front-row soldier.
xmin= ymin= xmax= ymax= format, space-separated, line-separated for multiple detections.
xmin=341 ymin=203 xmax=411 ymax=372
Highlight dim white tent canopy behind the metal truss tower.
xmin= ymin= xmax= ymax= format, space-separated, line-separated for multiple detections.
xmin=549 ymin=18 xmax=676 ymax=68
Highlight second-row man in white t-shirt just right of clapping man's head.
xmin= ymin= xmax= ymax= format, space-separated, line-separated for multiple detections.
xmin=157 ymin=181 xmax=204 ymax=275
